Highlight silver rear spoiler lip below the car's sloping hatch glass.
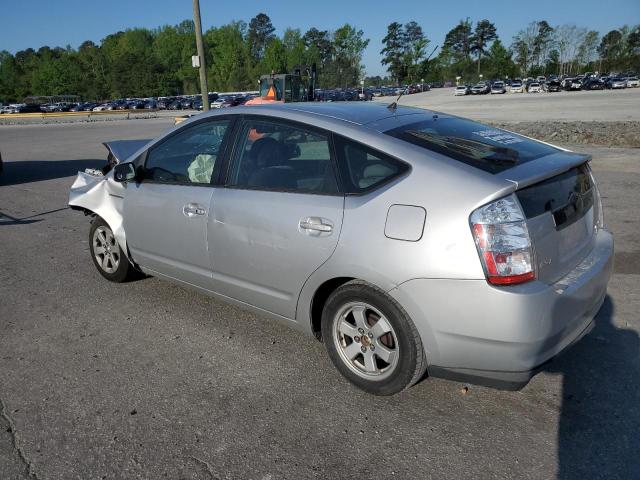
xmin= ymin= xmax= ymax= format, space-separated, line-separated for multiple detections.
xmin=496 ymin=151 xmax=591 ymax=188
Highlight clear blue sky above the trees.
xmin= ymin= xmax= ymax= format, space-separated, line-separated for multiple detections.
xmin=0 ymin=0 xmax=640 ymax=75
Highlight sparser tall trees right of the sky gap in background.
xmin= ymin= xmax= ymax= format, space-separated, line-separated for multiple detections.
xmin=378 ymin=18 xmax=640 ymax=84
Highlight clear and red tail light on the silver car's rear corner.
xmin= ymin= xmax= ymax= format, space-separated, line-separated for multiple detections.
xmin=470 ymin=194 xmax=536 ymax=285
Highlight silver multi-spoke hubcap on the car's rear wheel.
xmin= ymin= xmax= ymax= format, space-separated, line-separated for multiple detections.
xmin=333 ymin=302 xmax=398 ymax=380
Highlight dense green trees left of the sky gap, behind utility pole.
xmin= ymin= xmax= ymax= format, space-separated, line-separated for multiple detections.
xmin=0 ymin=13 xmax=369 ymax=103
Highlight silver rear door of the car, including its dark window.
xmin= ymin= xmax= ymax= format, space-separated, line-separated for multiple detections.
xmin=209 ymin=117 xmax=344 ymax=319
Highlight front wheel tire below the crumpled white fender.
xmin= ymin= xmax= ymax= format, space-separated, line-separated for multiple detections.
xmin=89 ymin=216 xmax=140 ymax=283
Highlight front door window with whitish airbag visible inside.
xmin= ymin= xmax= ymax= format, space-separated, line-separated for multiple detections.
xmin=143 ymin=120 xmax=230 ymax=184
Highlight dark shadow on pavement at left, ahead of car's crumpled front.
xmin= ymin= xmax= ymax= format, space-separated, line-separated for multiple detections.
xmin=0 ymin=158 xmax=106 ymax=186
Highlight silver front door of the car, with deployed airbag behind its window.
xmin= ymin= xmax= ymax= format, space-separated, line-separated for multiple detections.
xmin=124 ymin=118 xmax=231 ymax=288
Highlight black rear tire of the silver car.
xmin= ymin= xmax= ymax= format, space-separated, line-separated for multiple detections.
xmin=322 ymin=280 xmax=427 ymax=395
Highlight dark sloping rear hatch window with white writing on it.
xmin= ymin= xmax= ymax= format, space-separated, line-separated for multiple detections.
xmin=385 ymin=115 xmax=560 ymax=173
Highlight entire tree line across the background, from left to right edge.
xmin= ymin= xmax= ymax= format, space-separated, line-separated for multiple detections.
xmin=0 ymin=13 xmax=640 ymax=103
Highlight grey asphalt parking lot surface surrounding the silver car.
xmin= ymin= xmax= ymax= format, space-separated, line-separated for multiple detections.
xmin=0 ymin=96 xmax=640 ymax=480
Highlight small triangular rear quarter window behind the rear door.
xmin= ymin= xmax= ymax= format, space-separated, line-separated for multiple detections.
xmin=336 ymin=137 xmax=409 ymax=193
